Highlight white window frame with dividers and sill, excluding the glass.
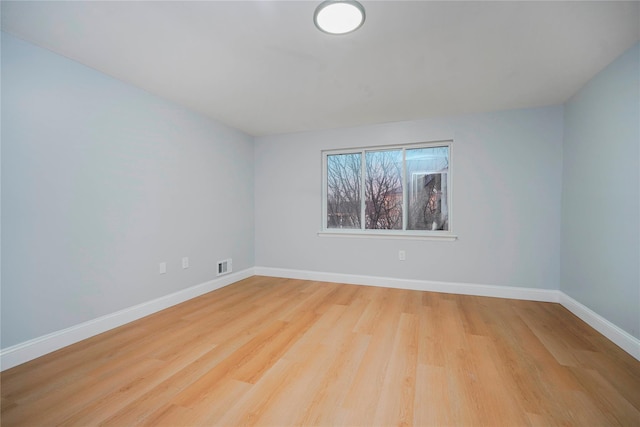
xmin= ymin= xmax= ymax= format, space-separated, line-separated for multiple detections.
xmin=318 ymin=140 xmax=458 ymax=241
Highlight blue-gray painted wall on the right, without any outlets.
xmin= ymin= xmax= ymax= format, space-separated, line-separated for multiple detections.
xmin=560 ymin=44 xmax=640 ymax=338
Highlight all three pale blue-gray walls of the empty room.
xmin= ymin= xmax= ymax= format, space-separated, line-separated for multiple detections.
xmin=1 ymin=33 xmax=640 ymax=348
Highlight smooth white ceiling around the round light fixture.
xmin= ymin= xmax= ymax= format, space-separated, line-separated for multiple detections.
xmin=2 ymin=0 xmax=640 ymax=136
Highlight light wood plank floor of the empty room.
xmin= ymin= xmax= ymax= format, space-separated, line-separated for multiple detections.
xmin=1 ymin=276 xmax=640 ymax=427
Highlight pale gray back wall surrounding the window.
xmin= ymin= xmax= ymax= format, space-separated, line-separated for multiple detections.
xmin=255 ymin=106 xmax=563 ymax=289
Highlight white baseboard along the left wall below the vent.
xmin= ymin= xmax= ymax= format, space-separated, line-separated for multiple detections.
xmin=0 ymin=268 xmax=254 ymax=370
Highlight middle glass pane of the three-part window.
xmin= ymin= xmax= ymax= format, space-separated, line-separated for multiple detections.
xmin=365 ymin=150 xmax=402 ymax=230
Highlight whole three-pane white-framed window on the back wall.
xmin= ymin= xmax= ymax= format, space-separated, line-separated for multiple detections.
xmin=322 ymin=142 xmax=455 ymax=238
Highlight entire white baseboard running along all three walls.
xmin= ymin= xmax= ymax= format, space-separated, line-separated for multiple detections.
xmin=0 ymin=267 xmax=640 ymax=371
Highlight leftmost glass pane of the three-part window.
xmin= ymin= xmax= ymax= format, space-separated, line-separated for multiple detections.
xmin=327 ymin=153 xmax=362 ymax=228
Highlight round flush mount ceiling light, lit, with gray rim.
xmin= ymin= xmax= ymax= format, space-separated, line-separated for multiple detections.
xmin=313 ymin=0 xmax=364 ymax=34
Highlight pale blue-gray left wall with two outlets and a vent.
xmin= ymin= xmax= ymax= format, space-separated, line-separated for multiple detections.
xmin=1 ymin=33 xmax=254 ymax=348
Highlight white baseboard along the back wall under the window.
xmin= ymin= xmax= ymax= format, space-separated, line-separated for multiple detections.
xmin=254 ymin=267 xmax=560 ymax=302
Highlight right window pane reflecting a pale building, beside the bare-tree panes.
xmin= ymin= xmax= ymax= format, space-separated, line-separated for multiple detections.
xmin=406 ymin=147 xmax=449 ymax=230
